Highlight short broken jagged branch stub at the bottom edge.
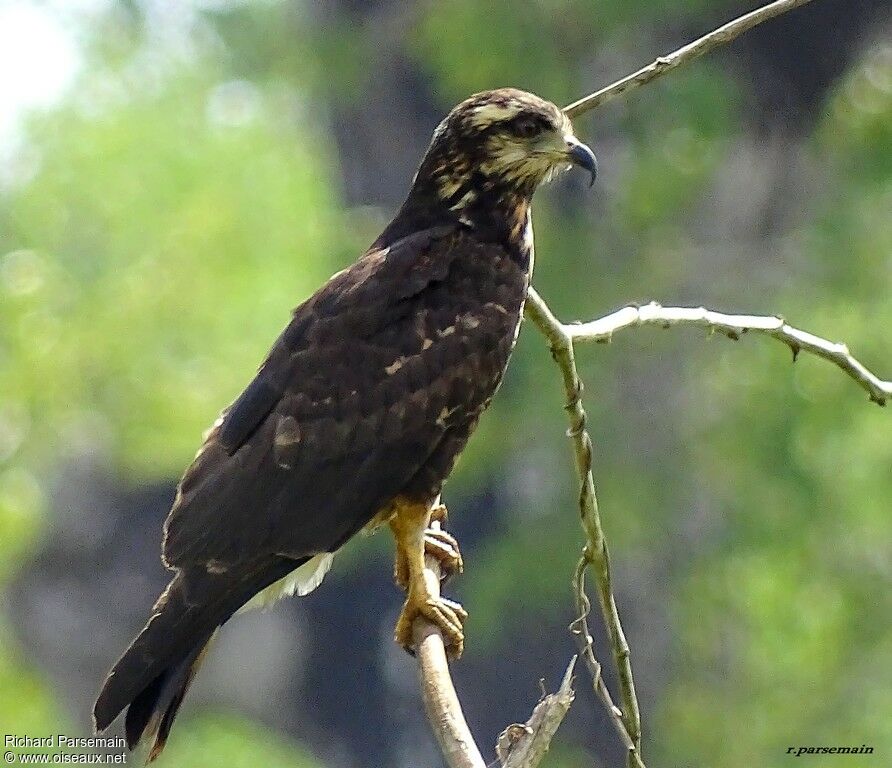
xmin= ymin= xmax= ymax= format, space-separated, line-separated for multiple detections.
xmin=496 ymin=656 xmax=576 ymax=768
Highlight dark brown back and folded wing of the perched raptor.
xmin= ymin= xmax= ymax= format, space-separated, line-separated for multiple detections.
xmin=165 ymin=226 xmax=529 ymax=568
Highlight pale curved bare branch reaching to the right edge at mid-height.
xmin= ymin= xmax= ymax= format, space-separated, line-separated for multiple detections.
xmin=562 ymin=302 xmax=892 ymax=405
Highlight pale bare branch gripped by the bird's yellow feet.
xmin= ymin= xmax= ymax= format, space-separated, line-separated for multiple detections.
xmin=414 ymin=522 xmax=486 ymax=768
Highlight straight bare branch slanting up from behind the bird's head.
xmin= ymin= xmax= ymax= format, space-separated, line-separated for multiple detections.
xmin=564 ymin=0 xmax=811 ymax=118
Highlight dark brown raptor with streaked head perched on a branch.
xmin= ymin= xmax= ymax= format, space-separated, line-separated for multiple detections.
xmin=93 ymin=88 xmax=597 ymax=762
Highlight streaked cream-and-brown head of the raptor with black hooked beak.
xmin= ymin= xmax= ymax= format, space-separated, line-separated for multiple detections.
xmin=416 ymin=88 xmax=597 ymax=209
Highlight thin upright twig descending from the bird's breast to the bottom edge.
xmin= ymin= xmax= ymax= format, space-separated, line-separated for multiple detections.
xmin=525 ymin=288 xmax=643 ymax=766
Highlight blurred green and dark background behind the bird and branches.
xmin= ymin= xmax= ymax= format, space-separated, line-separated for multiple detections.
xmin=0 ymin=0 xmax=892 ymax=768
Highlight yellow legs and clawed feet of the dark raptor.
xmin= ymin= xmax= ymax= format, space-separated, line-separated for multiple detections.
xmin=390 ymin=500 xmax=467 ymax=658
